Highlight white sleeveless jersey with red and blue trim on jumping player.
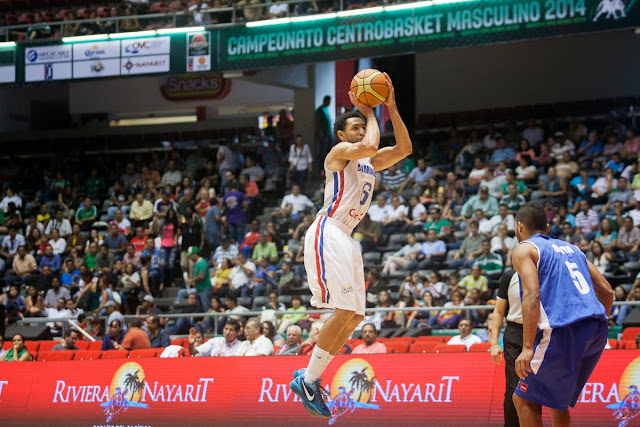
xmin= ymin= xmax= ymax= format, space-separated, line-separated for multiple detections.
xmin=318 ymin=157 xmax=376 ymax=230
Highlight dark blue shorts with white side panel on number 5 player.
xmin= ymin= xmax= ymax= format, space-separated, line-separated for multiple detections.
xmin=515 ymin=317 xmax=608 ymax=411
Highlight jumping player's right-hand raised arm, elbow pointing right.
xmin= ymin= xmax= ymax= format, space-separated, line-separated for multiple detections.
xmin=371 ymin=73 xmax=413 ymax=171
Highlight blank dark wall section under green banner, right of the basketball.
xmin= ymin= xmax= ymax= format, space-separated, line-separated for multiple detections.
xmin=416 ymin=30 xmax=640 ymax=115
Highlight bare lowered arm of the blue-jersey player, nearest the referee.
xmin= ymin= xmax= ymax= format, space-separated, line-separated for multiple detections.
xmin=511 ymin=244 xmax=540 ymax=378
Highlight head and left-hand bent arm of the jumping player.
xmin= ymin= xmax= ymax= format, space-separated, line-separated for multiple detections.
xmin=327 ymin=91 xmax=380 ymax=171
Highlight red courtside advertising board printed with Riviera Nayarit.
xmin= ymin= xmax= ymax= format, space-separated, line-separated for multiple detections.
xmin=0 ymin=350 xmax=640 ymax=426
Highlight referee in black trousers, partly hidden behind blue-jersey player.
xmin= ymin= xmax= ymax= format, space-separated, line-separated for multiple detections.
xmin=489 ymin=268 xmax=522 ymax=427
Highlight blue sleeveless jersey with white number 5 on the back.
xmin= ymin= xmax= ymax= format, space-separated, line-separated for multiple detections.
xmin=520 ymin=234 xmax=607 ymax=329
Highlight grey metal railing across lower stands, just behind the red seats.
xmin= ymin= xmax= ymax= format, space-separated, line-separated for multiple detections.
xmin=17 ymin=301 xmax=640 ymax=335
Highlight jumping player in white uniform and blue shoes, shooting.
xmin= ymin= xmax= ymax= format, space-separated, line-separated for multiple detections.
xmin=290 ymin=73 xmax=412 ymax=418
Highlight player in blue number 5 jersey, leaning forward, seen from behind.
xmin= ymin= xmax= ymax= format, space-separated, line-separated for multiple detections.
xmin=512 ymin=202 xmax=613 ymax=427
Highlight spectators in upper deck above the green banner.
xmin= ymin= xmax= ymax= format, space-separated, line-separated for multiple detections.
xmin=0 ymin=0 xmax=400 ymax=41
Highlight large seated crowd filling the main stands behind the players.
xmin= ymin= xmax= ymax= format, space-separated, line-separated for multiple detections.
xmin=0 ymin=108 xmax=640 ymax=357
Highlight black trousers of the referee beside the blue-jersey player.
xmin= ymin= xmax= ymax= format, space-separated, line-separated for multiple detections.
xmin=503 ymin=322 xmax=522 ymax=427
